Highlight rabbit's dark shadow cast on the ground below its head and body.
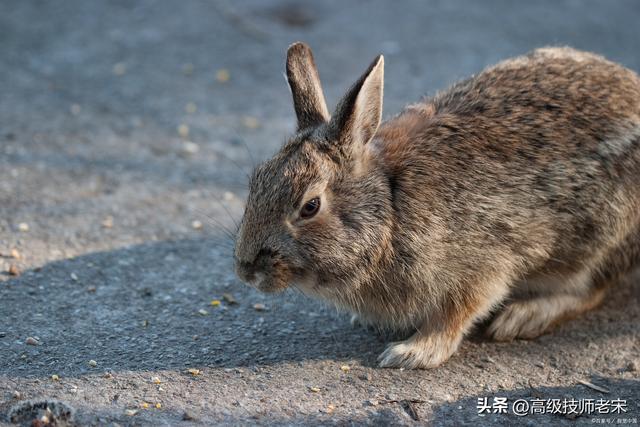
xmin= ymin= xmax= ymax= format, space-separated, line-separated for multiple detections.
xmin=0 ymin=237 xmax=640 ymax=376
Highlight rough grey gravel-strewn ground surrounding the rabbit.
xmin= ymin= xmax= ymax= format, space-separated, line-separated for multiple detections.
xmin=0 ymin=0 xmax=640 ymax=426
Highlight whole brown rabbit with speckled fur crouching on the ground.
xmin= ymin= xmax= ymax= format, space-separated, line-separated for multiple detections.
xmin=235 ymin=43 xmax=640 ymax=368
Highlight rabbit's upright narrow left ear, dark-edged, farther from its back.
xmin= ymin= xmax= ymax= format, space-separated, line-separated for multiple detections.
xmin=287 ymin=42 xmax=329 ymax=130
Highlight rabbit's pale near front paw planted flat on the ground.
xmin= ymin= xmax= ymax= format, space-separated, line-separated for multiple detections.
xmin=378 ymin=333 xmax=460 ymax=369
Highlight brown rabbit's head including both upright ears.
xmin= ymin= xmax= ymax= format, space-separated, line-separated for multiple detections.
xmin=234 ymin=43 xmax=392 ymax=294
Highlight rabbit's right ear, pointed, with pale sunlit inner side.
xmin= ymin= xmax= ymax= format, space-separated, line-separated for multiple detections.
xmin=329 ymin=55 xmax=384 ymax=145
